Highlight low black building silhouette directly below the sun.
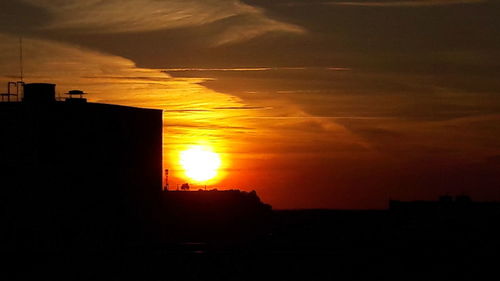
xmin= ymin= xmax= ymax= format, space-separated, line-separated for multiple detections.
xmin=160 ymin=189 xmax=272 ymax=241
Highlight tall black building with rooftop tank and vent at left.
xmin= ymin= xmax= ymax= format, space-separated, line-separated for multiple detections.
xmin=0 ymin=84 xmax=162 ymax=247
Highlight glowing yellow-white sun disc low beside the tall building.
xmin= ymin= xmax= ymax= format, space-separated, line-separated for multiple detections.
xmin=180 ymin=146 xmax=221 ymax=182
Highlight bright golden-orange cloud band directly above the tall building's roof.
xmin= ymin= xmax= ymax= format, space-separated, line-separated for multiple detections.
xmin=0 ymin=33 xmax=252 ymax=115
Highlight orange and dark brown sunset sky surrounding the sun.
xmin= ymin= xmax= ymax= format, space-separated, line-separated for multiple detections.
xmin=0 ymin=0 xmax=500 ymax=209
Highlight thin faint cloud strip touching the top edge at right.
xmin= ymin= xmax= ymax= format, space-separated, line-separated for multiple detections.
xmin=328 ymin=0 xmax=486 ymax=7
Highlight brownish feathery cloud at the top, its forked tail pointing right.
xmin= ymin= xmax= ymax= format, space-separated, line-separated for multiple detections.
xmin=22 ymin=0 xmax=304 ymax=45
